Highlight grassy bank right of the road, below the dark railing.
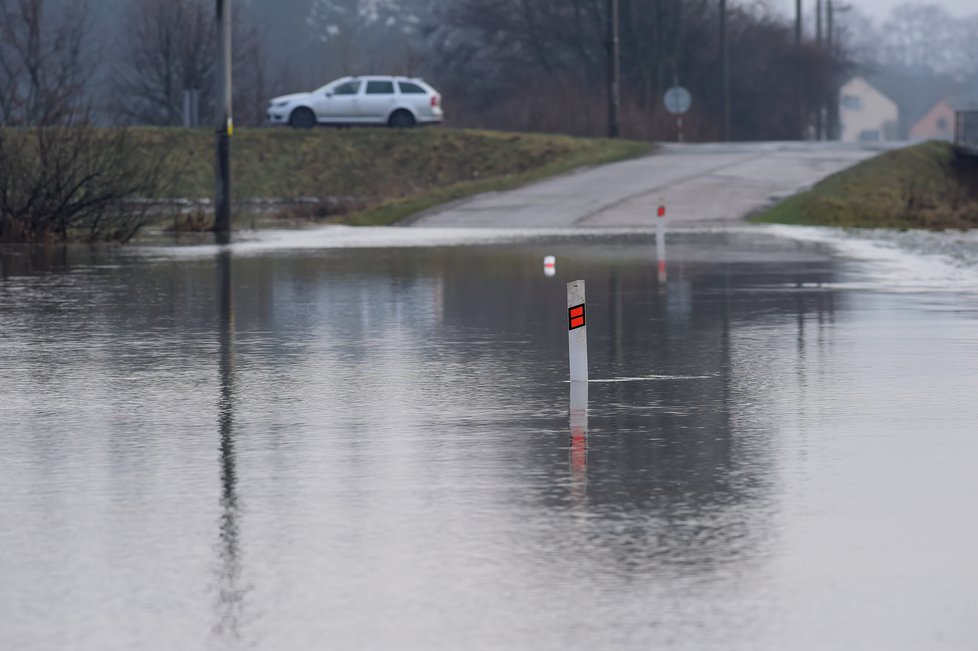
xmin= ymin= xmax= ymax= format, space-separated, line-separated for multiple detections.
xmin=752 ymin=142 xmax=978 ymax=229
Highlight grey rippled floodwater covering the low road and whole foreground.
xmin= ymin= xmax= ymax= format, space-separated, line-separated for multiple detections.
xmin=0 ymin=229 xmax=978 ymax=651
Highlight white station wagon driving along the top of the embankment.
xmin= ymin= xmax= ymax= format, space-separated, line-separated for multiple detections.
xmin=268 ymin=76 xmax=444 ymax=129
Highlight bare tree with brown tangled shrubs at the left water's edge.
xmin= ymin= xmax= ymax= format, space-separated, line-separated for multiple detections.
xmin=0 ymin=0 xmax=175 ymax=242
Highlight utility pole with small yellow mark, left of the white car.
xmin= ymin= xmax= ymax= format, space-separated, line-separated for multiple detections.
xmin=214 ymin=0 xmax=234 ymax=241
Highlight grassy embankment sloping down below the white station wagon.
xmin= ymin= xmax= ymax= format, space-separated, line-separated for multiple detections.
xmin=136 ymin=128 xmax=650 ymax=225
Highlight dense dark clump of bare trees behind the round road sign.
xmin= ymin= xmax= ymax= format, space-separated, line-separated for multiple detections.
xmin=428 ymin=0 xmax=846 ymax=139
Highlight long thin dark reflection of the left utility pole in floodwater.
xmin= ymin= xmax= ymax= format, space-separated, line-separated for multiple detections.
xmin=214 ymin=249 xmax=245 ymax=642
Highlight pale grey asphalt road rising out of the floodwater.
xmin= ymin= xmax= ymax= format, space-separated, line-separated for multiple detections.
xmin=411 ymin=142 xmax=893 ymax=229
